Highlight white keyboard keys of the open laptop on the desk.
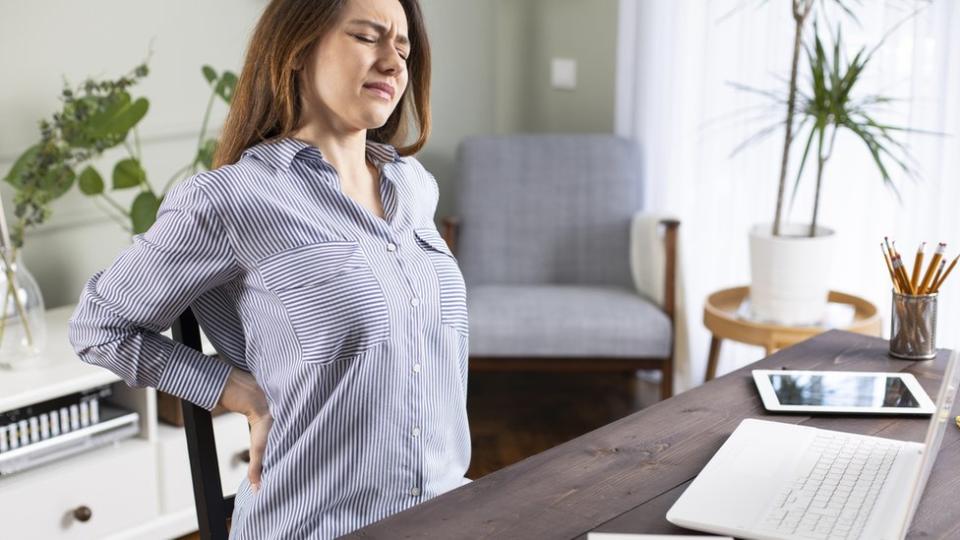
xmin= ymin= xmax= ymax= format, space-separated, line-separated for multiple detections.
xmin=760 ymin=433 xmax=900 ymax=540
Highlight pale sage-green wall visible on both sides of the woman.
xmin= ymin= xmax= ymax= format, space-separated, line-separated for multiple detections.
xmin=0 ymin=0 xmax=617 ymax=307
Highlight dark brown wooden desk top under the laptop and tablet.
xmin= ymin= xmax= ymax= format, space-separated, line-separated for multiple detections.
xmin=351 ymin=331 xmax=960 ymax=540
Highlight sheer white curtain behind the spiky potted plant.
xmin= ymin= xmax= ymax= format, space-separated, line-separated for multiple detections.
xmin=616 ymin=0 xmax=960 ymax=387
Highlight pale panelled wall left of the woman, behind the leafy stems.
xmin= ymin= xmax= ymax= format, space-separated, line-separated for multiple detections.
xmin=0 ymin=0 xmax=265 ymax=307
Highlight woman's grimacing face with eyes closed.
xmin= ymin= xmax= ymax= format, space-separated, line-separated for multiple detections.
xmin=304 ymin=0 xmax=410 ymax=132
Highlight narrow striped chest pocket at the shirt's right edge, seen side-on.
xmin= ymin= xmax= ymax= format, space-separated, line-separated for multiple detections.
xmin=413 ymin=227 xmax=469 ymax=335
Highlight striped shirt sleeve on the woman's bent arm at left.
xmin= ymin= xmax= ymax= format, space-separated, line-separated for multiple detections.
xmin=69 ymin=177 xmax=239 ymax=410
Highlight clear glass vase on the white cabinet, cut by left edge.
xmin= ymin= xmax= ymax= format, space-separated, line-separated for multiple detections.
xmin=0 ymin=248 xmax=47 ymax=369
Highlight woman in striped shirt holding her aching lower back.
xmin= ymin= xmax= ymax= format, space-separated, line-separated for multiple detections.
xmin=70 ymin=0 xmax=470 ymax=540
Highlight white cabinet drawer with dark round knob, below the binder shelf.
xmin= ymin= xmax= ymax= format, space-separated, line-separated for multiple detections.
xmin=0 ymin=439 xmax=159 ymax=540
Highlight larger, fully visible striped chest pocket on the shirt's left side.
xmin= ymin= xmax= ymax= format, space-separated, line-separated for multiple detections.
xmin=259 ymin=241 xmax=390 ymax=364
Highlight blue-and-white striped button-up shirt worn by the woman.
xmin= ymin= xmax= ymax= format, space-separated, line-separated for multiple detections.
xmin=69 ymin=138 xmax=470 ymax=540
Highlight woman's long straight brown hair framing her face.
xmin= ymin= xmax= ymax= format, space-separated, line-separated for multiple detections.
xmin=213 ymin=0 xmax=430 ymax=168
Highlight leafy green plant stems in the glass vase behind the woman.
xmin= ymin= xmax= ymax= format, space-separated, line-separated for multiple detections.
xmin=0 ymin=62 xmax=237 ymax=350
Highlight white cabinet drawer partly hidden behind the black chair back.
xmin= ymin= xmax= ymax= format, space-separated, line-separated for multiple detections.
xmin=158 ymin=413 xmax=250 ymax=513
